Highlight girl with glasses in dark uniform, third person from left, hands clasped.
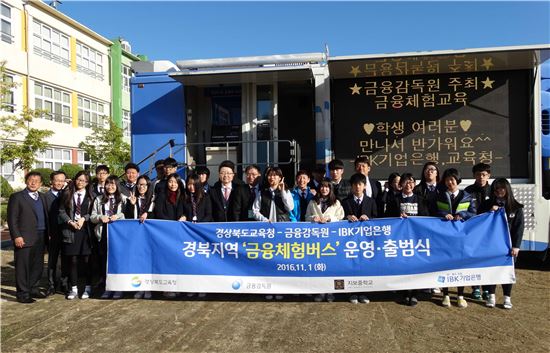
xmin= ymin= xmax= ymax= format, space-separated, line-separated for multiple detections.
xmin=59 ymin=170 xmax=93 ymax=300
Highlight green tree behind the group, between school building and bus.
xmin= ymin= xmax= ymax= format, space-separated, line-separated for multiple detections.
xmin=78 ymin=120 xmax=130 ymax=175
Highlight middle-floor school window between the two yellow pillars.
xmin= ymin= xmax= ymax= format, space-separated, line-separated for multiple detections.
xmin=34 ymin=82 xmax=72 ymax=124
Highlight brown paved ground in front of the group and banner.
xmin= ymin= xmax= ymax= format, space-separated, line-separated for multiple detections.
xmin=1 ymin=250 xmax=550 ymax=353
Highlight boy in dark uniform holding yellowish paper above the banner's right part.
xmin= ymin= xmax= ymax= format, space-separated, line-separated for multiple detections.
xmin=435 ymin=168 xmax=476 ymax=308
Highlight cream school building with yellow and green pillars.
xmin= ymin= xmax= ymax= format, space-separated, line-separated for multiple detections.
xmin=0 ymin=0 xmax=140 ymax=187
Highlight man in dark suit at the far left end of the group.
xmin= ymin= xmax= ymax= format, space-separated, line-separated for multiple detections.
xmin=8 ymin=172 xmax=48 ymax=303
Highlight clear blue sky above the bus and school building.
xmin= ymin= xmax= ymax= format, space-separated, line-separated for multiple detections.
xmin=57 ymin=0 xmax=550 ymax=62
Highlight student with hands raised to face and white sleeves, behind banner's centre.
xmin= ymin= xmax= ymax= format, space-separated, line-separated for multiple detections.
xmin=252 ymin=167 xmax=294 ymax=300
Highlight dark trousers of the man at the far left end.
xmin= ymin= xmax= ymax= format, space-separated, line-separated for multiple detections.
xmin=14 ymin=232 xmax=44 ymax=299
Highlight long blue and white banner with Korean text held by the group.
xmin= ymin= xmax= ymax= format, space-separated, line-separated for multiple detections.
xmin=107 ymin=211 xmax=515 ymax=293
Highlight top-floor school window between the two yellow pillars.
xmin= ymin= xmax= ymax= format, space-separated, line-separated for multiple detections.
xmin=33 ymin=20 xmax=71 ymax=67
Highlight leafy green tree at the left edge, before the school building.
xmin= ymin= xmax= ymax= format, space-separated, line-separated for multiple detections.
xmin=0 ymin=61 xmax=53 ymax=170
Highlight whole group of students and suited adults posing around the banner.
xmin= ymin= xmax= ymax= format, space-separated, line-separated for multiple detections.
xmin=8 ymin=157 xmax=523 ymax=309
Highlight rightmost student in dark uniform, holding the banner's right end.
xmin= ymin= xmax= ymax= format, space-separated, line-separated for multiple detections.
xmin=479 ymin=178 xmax=525 ymax=309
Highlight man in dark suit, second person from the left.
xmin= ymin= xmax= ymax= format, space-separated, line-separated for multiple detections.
xmin=45 ymin=171 xmax=67 ymax=295
